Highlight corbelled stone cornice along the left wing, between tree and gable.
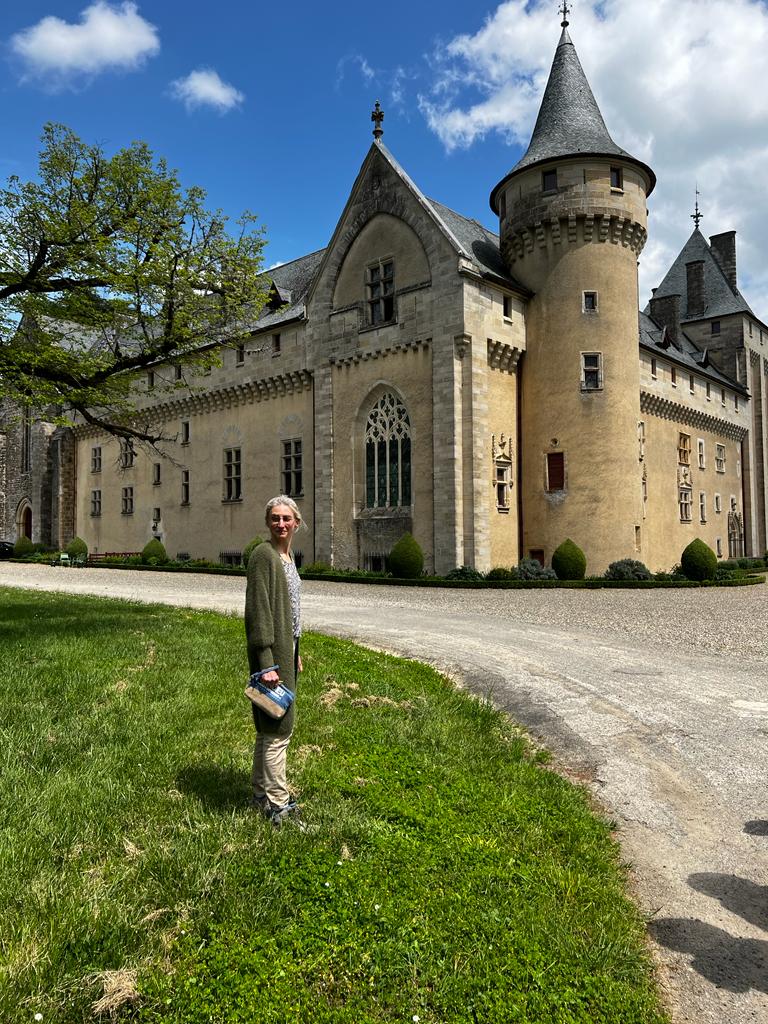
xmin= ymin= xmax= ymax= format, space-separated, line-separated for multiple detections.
xmin=75 ymin=370 xmax=312 ymax=437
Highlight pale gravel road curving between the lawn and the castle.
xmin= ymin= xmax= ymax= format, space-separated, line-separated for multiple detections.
xmin=0 ymin=563 xmax=768 ymax=1024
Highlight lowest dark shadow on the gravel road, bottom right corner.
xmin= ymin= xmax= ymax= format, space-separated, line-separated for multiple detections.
xmin=648 ymin=918 xmax=768 ymax=992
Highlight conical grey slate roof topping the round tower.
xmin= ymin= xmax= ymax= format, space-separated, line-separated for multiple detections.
xmin=490 ymin=28 xmax=656 ymax=212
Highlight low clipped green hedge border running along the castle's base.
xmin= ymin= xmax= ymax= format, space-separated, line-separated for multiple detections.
xmin=6 ymin=558 xmax=766 ymax=590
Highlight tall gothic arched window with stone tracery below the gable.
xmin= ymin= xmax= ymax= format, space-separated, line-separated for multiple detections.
xmin=366 ymin=391 xmax=411 ymax=509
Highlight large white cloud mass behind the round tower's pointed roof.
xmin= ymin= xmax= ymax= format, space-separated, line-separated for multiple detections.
xmin=419 ymin=0 xmax=768 ymax=318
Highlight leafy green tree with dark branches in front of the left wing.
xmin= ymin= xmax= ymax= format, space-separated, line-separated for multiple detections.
xmin=0 ymin=124 xmax=266 ymax=443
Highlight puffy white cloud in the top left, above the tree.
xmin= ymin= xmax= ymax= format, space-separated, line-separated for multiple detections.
xmin=10 ymin=0 xmax=160 ymax=84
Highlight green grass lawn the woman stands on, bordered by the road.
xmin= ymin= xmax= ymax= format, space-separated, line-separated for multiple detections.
xmin=0 ymin=590 xmax=666 ymax=1024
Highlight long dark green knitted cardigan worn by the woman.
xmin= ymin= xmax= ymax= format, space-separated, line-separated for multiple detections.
xmin=246 ymin=542 xmax=296 ymax=736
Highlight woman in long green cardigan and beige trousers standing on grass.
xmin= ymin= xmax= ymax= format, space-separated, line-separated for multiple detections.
xmin=246 ymin=495 xmax=301 ymax=825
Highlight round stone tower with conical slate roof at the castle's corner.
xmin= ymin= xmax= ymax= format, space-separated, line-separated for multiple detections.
xmin=490 ymin=22 xmax=655 ymax=573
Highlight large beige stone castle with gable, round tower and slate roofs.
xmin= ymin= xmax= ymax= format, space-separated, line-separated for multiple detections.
xmin=0 ymin=22 xmax=768 ymax=573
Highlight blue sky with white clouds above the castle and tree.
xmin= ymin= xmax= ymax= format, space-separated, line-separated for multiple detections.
xmin=0 ymin=0 xmax=768 ymax=311
